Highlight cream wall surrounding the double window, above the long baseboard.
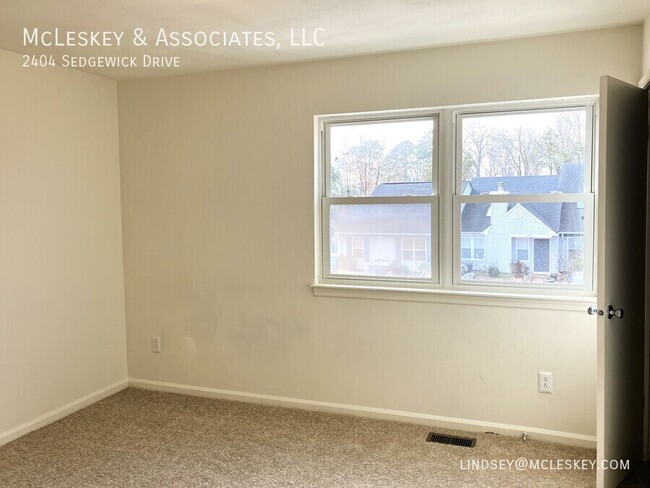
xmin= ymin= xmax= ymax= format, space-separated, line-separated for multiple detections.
xmin=119 ymin=26 xmax=642 ymax=436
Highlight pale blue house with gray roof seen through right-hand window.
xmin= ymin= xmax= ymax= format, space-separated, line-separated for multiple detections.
xmin=460 ymin=163 xmax=584 ymax=282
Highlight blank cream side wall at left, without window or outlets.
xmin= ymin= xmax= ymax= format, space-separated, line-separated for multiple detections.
xmin=0 ymin=50 xmax=126 ymax=443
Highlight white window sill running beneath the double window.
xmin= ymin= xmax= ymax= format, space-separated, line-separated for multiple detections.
xmin=311 ymin=284 xmax=596 ymax=313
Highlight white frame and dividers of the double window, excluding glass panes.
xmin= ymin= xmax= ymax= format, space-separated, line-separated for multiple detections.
xmin=312 ymin=95 xmax=598 ymax=304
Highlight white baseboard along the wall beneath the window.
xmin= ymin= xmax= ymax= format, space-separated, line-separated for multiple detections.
xmin=129 ymin=378 xmax=596 ymax=449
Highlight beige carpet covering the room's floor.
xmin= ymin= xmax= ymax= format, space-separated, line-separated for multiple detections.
xmin=0 ymin=389 xmax=595 ymax=488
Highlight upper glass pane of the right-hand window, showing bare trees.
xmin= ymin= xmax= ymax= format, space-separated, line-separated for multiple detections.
xmin=461 ymin=109 xmax=587 ymax=194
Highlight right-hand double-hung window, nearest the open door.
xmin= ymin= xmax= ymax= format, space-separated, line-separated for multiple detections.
xmin=453 ymin=104 xmax=594 ymax=293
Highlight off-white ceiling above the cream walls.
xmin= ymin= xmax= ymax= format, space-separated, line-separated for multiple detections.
xmin=0 ymin=0 xmax=650 ymax=79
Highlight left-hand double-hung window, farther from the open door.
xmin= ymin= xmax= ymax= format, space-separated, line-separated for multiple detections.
xmin=319 ymin=113 xmax=438 ymax=286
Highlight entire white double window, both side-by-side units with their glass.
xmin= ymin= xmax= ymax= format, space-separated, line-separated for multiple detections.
xmin=316 ymin=98 xmax=595 ymax=296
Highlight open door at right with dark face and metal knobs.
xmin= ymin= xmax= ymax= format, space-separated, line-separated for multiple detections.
xmin=596 ymin=76 xmax=648 ymax=488
